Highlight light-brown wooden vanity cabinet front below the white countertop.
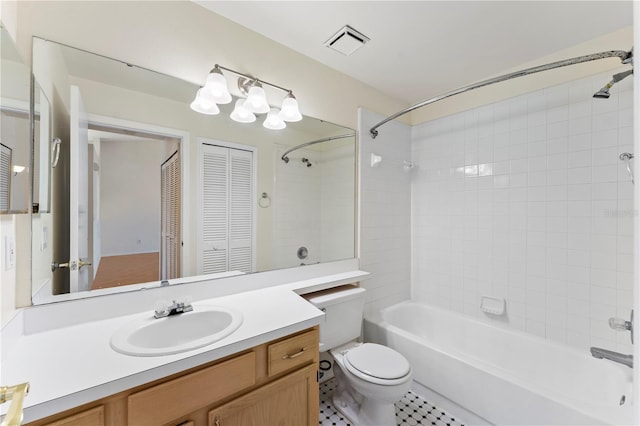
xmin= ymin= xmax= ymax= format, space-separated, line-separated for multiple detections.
xmin=30 ymin=327 xmax=319 ymax=426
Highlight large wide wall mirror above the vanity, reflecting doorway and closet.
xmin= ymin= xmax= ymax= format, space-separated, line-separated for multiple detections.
xmin=32 ymin=37 xmax=356 ymax=304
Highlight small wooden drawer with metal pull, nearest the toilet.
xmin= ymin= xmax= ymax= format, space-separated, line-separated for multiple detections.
xmin=267 ymin=329 xmax=319 ymax=377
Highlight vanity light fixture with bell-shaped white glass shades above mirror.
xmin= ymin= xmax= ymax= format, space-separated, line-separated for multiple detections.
xmin=191 ymin=64 xmax=302 ymax=130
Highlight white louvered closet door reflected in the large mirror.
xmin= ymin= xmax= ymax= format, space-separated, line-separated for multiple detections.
xmin=200 ymin=144 xmax=255 ymax=274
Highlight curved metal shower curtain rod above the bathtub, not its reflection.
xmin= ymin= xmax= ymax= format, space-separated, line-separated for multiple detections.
xmin=369 ymin=49 xmax=633 ymax=139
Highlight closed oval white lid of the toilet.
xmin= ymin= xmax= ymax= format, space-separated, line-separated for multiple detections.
xmin=345 ymin=343 xmax=411 ymax=380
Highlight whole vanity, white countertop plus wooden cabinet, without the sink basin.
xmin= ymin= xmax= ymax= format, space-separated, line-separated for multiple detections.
xmin=0 ymin=263 xmax=369 ymax=426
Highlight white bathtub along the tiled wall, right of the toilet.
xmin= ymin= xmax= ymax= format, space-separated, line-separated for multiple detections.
xmin=365 ymin=302 xmax=633 ymax=425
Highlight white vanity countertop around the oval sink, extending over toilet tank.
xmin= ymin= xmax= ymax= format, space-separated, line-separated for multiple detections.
xmin=2 ymin=271 xmax=368 ymax=422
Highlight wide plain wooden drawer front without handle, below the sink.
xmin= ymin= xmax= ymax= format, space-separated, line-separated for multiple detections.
xmin=128 ymin=352 xmax=256 ymax=426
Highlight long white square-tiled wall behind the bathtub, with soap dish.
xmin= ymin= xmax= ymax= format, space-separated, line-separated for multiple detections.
xmin=412 ymin=69 xmax=637 ymax=353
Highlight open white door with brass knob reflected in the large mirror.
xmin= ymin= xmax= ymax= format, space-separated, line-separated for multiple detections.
xmin=69 ymin=86 xmax=93 ymax=293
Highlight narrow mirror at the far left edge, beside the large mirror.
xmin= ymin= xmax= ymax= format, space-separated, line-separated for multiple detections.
xmin=0 ymin=26 xmax=31 ymax=214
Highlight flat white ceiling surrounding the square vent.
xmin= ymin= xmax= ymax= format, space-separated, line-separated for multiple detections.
xmin=194 ymin=0 xmax=633 ymax=104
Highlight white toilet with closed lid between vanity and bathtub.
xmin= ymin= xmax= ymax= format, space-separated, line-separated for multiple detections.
xmin=307 ymin=286 xmax=413 ymax=426
